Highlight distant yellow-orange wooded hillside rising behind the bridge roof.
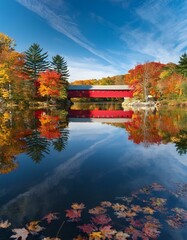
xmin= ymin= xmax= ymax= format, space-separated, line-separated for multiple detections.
xmin=71 ymin=75 xmax=125 ymax=85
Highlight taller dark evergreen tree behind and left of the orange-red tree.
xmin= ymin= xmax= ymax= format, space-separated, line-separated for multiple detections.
xmin=24 ymin=43 xmax=49 ymax=81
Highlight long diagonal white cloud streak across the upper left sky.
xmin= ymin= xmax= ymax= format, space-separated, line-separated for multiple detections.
xmin=16 ymin=0 xmax=113 ymax=64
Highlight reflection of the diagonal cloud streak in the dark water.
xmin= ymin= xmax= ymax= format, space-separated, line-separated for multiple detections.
xmin=0 ymin=133 xmax=113 ymax=226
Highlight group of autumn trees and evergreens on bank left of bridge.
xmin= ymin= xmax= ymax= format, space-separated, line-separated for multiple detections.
xmin=0 ymin=33 xmax=69 ymax=103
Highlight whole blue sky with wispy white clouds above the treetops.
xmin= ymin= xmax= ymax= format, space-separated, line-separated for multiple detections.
xmin=0 ymin=0 xmax=187 ymax=81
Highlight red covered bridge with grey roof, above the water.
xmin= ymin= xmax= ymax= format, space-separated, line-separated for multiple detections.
xmin=68 ymin=85 xmax=133 ymax=98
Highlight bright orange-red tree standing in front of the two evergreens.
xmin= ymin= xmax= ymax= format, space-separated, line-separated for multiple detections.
xmin=37 ymin=70 xmax=61 ymax=102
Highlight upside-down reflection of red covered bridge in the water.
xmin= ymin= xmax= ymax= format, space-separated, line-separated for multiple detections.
xmin=68 ymin=110 xmax=133 ymax=122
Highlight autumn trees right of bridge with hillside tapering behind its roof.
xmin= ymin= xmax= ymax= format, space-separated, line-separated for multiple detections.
xmin=72 ymin=57 xmax=187 ymax=101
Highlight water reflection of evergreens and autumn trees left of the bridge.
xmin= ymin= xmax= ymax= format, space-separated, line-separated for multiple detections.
xmin=0 ymin=110 xmax=69 ymax=174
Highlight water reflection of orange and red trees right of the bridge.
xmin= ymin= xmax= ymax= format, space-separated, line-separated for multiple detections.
xmin=108 ymin=109 xmax=187 ymax=154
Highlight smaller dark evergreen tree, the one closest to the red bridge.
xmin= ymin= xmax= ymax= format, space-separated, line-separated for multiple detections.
xmin=51 ymin=55 xmax=69 ymax=83
